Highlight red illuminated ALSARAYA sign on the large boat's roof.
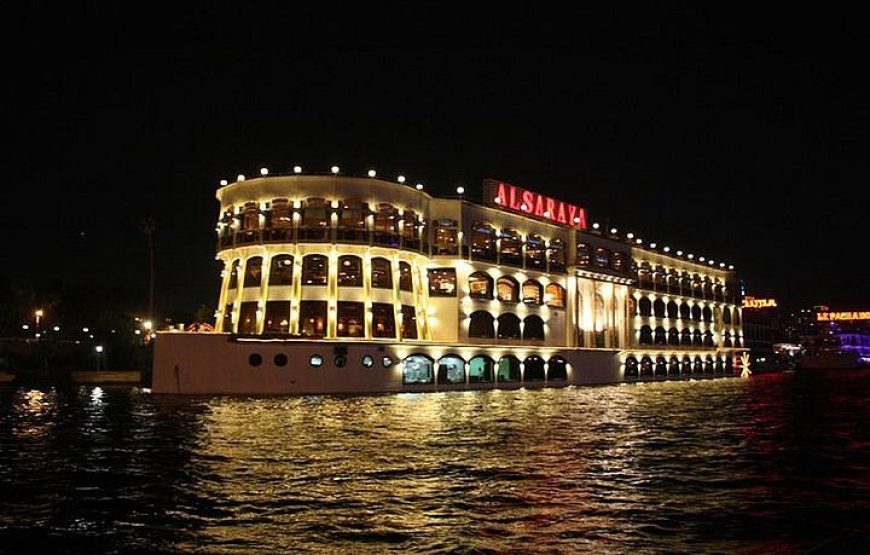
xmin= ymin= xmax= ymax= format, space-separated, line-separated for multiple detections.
xmin=483 ymin=179 xmax=586 ymax=229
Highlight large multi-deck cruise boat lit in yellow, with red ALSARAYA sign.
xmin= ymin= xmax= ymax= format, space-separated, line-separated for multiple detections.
xmin=152 ymin=168 xmax=746 ymax=394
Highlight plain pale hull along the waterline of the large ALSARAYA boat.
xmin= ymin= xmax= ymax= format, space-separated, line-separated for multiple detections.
xmin=152 ymin=333 xmax=740 ymax=395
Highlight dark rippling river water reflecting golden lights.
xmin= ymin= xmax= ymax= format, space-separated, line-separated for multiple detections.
xmin=0 ymin=371 xmax=870 ymax=553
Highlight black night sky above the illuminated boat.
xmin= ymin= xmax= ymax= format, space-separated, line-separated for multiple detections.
xmin=0 ymin=4 xmax=870 ymax=318
